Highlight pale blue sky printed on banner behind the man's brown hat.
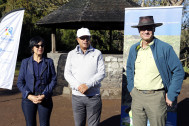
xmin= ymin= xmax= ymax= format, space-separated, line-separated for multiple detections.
xmin=124 ymin=6 xmax=182 ymax=35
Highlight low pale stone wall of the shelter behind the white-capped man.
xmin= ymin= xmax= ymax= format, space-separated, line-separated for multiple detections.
xmin=47 ymin=53 xmax=123 ymax=99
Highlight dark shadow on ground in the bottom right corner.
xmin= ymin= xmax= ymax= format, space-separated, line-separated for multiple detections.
xmin=177 ymin=98 xmax=189 ymax=126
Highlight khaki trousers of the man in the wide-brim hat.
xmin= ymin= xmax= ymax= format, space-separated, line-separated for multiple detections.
xmin=131 ymin=88 xmax=167 ymax=126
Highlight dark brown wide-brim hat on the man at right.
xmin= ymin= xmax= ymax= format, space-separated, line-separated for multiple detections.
xmin=131 ymin=16 xmax=163 ymax=28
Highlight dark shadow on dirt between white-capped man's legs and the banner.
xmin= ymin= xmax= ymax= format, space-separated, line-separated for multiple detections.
xmin=100 ymin=115 xmax=121 ymax=126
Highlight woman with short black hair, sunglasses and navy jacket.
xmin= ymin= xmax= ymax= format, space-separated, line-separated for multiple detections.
xmin=17 ymin=36 xmax=56 ymax=126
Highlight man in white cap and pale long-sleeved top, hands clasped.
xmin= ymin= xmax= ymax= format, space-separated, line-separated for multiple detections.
xmin=64 ymin=28 xmax=105 ymax=126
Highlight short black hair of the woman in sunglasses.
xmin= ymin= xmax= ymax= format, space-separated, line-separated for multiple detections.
xmin=29 ymin=36 xmax=45 ymax=54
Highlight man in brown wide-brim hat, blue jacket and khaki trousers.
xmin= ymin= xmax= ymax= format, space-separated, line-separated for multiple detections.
xmin=126 ymin=16 xmax=184 ymax=126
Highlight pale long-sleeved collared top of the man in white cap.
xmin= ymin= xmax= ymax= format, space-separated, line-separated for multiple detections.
xmin=64 ymin=45 xmax=105 ymax=96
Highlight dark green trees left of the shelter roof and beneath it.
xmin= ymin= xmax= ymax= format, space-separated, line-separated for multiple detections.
xmin=0 ymin=0 xmax=123 ymax=55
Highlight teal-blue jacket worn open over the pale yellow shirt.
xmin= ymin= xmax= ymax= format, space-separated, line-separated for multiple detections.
xmin=126 ymin=38 xmax=185 ymax=101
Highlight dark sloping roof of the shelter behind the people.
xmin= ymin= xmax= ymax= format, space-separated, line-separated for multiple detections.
xmin=36 ymin=0 xmax=139 ymax=30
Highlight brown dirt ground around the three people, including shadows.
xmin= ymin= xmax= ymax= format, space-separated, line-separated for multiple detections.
xmin=0 ymin=79 xmax=189 ymax=126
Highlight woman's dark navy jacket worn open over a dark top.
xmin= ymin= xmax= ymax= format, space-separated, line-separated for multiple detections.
xmin=17 ymin=56 xmax=57 ymax=98
